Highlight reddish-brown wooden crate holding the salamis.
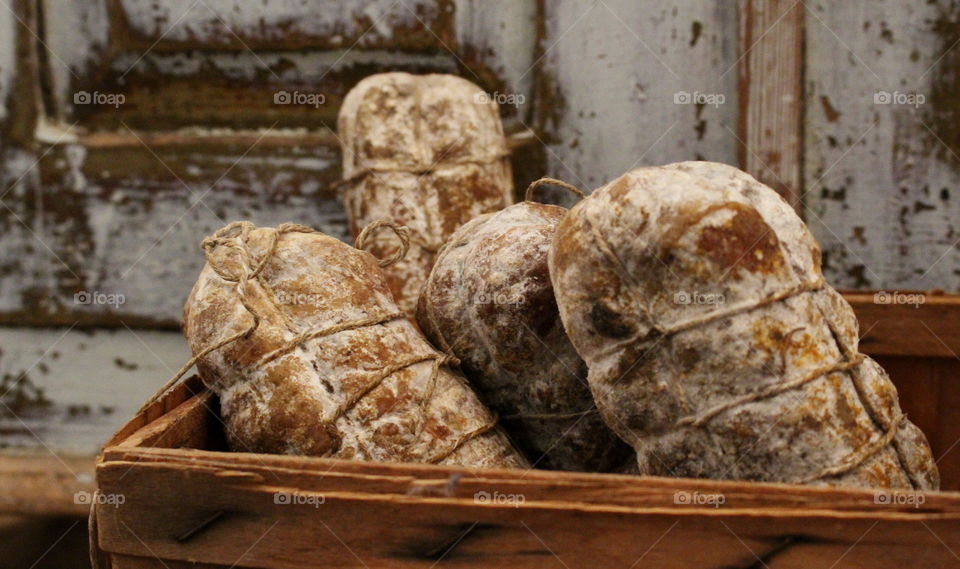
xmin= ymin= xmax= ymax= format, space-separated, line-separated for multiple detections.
xmin=92 ymin=294 xmax=960 ymax=569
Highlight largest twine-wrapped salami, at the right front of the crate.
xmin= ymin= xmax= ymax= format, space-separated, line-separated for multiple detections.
xmin=550 ymin=162 xmax=939 ymax=490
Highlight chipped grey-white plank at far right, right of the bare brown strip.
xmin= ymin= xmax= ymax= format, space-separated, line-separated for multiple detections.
xmin=804 ymin=0 xmax=960 ymax=292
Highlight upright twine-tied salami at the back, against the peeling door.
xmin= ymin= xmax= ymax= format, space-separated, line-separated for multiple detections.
xmin=337 ymin=72 xmax=513 ymax=317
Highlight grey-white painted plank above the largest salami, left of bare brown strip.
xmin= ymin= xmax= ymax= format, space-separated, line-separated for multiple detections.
xmin=544 ymin=0 xmax=739 ymax=189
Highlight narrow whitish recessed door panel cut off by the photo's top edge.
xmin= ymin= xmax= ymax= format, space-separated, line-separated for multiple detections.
xmin=111 ymin=0 xmax=456 ymax=51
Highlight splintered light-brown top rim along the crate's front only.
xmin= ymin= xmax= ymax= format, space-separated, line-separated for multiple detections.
xmin=98 ymin=450 xmax=960 ymax=515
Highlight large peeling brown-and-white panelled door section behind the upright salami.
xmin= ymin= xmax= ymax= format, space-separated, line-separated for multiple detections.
xmin=0 ymin=0 xmax=542 ymax=327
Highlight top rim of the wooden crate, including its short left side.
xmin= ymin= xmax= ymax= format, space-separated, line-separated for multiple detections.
xmin=92 ymin=379 xmax=960 ymax=511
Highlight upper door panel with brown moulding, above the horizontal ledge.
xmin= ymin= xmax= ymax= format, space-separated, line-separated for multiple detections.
xmin=45 ymin=0 xmax=535 ymax=130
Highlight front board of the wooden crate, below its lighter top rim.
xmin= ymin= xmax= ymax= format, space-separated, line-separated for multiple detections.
xmin=90 ymin=468 xmax=960 ymax=568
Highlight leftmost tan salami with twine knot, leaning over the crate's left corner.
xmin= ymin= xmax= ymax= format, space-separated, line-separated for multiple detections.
xmin=184 ymin=221 xmax=527 ymax=467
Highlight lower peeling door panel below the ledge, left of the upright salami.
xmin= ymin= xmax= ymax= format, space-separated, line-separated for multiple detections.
xmin=0 ymin=138 xmax=346 ymax=327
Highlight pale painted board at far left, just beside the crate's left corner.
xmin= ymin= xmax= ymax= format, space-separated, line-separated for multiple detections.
xmin=0 ymin=328 xmax=190 ymax=455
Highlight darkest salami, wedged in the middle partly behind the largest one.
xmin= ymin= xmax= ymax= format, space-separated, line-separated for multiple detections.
xmin=417 ymin=202 xmax=634 ymax=472
